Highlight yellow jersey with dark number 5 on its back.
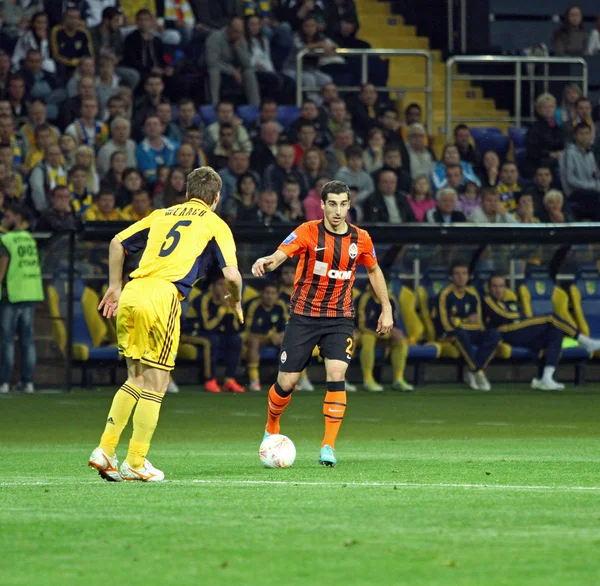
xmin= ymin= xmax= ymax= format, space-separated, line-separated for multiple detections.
xmin=116 ymin=199 xmax=237 ymax=299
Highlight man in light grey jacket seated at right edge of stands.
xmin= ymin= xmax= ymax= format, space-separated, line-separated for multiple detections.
xmin=562 ymin=122 xmax=600 ymax=222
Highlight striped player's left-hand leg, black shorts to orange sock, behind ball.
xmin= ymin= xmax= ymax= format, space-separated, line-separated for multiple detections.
xmin=265 ymin=315 xmax=320 ymax=435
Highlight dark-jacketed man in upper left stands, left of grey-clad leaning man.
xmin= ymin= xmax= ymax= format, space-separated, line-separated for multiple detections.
xmin=123 ymin=8 xmax=173 ymax=77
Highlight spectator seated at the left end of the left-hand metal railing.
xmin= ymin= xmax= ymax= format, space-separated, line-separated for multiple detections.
xmin=283 ymin=15 xmax=338 ymax=103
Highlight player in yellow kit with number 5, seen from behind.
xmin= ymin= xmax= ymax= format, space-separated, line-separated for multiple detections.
xmin=88 ymin=167 xmax=243 ymax=482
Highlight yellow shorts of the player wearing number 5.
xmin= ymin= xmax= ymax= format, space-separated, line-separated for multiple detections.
xmin=117 ymin=278 xmax=181 ymax=370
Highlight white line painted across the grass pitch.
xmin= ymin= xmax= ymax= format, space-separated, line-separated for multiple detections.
xmin=0 ymin=478 xmax=600 ymax=492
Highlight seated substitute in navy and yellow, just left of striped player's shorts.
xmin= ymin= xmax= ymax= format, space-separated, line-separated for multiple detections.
xmin=245 ymin=281 xmax=289 ymax=391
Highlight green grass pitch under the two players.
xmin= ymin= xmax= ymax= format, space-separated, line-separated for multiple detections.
xmin=0 ymin=385 xmax=600 ymax=586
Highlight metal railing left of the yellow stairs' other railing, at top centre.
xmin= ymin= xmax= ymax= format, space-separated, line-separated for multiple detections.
xmin=296 ymin=49 xmax=433 ymax=134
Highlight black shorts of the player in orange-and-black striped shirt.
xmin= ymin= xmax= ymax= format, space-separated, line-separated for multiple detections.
xmin=279 ymin=314 xmax=354 ymax=372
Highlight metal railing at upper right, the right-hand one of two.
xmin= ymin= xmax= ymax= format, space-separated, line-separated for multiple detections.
xmin=446 ymin=55 xmax=588 ymax=142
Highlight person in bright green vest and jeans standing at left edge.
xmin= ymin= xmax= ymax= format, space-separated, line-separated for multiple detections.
xmin=0 ymin=204 xmax=44 ymax=394
